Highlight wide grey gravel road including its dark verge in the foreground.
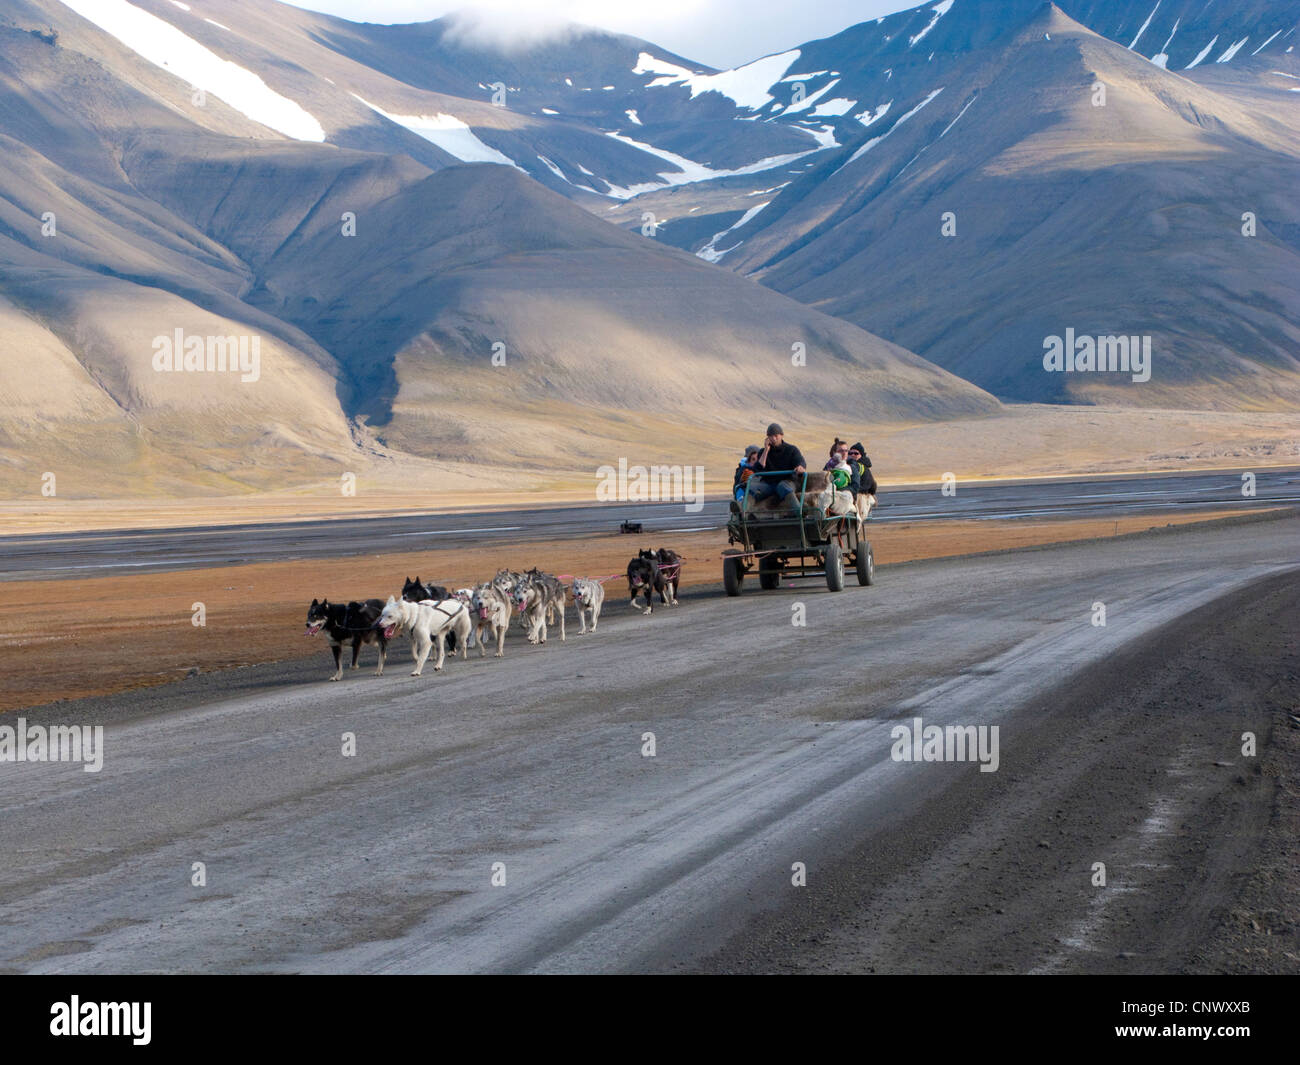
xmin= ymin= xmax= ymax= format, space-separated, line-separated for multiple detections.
xmin=0 ymin=516 xmax=1300 ymax=973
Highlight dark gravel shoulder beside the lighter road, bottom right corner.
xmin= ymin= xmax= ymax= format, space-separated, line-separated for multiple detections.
xmin=694 ymin=572 xmax=1300 ymax=973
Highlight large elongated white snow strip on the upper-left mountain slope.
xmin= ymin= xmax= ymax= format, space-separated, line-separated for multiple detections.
xmin=61 ymin=0 xmax=325 ymax=140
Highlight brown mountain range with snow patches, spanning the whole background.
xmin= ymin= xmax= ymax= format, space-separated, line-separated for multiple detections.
xmin=0 ymin=0 xmax=1300 ymax=495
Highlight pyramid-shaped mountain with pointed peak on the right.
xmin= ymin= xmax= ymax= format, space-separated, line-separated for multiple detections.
xmin=724 ymin=8 xmax=1300 ymax=410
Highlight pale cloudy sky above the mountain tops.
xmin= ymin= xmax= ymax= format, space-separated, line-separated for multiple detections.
xmin=286 ymin=0 xmax=918 ymax=68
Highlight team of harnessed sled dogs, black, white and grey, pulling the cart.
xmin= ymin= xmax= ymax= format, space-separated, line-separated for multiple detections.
xmin=307 ymin=549 xmax=683 ymax=680
